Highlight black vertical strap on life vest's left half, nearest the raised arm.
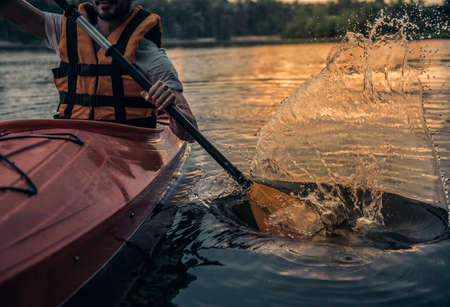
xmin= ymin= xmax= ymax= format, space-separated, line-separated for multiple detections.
xmin=64 ymin=17 xmax=78 ymax=118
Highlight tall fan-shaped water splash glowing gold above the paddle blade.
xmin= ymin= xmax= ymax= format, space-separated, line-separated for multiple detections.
xmin=252 ymin=12 xmax=447 ymax=236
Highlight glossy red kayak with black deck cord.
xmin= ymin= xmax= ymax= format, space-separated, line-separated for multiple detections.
xmin=0 ymin=120 xmax=186 ymax=307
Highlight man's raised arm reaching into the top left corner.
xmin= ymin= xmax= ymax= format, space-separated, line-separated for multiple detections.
xmin=0 ymin=0 xmax=45 ymax=37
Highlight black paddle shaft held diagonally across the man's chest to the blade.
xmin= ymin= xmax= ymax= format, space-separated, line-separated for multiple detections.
xmin=55 ymin=0 xmax=252 ymax=188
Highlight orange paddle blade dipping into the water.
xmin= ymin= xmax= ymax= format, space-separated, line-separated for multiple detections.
xmin=247 ymin=183 xmax=325 ymax=239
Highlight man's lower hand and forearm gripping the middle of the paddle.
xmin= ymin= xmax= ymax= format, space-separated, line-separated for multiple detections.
xmin=141 ymin=81 xmax=197 ymax=142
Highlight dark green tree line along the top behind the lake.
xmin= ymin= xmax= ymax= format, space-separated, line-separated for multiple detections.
xmin=0 ymin=0 xmax=450 ymax=43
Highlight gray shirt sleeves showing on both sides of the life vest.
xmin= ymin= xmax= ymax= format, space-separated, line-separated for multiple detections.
xmin=44 ymin=13 xmax=183 ymax=91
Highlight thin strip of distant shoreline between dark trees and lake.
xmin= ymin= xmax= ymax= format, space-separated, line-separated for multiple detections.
xmin=0 ymin=36 xmax=337 ymax=51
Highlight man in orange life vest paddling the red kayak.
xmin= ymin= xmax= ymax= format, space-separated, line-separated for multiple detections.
xmin=0 ymin=0 xmax=196 ymax=141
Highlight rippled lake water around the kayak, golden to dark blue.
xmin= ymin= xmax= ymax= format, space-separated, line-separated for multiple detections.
xmin=0 ymin=41 xmax=450 ymax=306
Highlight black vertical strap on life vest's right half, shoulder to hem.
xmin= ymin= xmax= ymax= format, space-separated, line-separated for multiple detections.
xmin=111 ymin=9 xmax=150 ymax=121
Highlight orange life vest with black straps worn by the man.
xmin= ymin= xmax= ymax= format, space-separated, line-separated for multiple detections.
xmin=53 ymin=2 xmax=162 ymax=121
